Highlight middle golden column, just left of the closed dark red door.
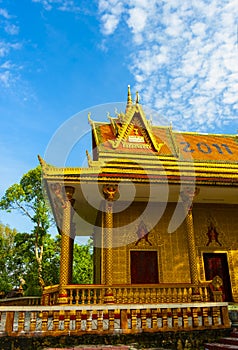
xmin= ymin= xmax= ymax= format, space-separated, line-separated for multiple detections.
xmin=103 ymin=185 xmax=118 ymax=303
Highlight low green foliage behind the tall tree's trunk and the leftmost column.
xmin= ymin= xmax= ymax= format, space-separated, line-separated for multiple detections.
xmin=0 ymin=223 xmax=93 ymax=296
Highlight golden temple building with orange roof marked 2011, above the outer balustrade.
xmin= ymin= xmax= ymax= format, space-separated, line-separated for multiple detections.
xmin=39 ymin=88 xmax=238 ymax=314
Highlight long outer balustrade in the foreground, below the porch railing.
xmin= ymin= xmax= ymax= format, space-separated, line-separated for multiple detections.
xmin=0 ymin=302 xmax=230 ymax=336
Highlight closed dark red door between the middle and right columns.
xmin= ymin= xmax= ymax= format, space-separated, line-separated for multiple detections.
xmin=130 ymin=250 xmax=159 ymax=284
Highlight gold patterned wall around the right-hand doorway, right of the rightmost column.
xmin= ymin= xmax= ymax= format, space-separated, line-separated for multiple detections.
xmin=193 ymin=204 xmax=238 ymax=301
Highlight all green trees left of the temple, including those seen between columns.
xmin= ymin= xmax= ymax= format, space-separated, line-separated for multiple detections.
xmin=0 ymin=167 xmax=93 ymax=295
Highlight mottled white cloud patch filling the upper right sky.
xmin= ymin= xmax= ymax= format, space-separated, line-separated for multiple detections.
xmin=99 ymin=0 xmax=238 ymax=131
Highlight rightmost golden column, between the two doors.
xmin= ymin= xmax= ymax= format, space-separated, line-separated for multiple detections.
xmin=181 ymin=188 xmax=201 ymax=301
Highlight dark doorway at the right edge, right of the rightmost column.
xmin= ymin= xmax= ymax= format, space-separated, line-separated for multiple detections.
xmin=203 ymin=253 xmax=232 ymax=301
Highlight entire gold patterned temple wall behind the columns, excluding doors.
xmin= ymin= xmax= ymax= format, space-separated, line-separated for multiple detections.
xmin=95 ymin=202 xmax=238 ymax=301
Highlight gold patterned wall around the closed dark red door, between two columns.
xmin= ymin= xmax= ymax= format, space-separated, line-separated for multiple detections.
xmin=103 ymin=202 xmax=190 ymax=284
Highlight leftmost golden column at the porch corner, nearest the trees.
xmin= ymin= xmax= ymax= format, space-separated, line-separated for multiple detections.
xmin=58 ymin=186 xmax=74 ymax=304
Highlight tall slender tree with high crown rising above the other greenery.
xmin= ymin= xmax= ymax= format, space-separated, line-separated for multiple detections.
xmin=0 ymin=166 xmax=51 ymax=288
